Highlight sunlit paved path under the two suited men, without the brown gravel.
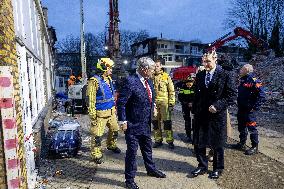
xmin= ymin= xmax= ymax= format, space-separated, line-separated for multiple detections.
xmin=38 ymin=112 xmax=218 ymax=189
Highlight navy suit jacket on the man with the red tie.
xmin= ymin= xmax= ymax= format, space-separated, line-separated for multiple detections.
xmin=117 ymin=74 xmax=155 ymax=135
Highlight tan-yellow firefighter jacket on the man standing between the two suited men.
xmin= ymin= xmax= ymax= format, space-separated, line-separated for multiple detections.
xmin=154 ymin=71 xmax=175 ymax=106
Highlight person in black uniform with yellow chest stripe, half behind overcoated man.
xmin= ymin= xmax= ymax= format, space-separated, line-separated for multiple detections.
xmin=177 ymin=74 xmax=195 ymax=143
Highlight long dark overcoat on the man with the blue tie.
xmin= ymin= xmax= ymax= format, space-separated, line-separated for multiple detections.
xmin=193 ymin=65 xmax=236 ymax=148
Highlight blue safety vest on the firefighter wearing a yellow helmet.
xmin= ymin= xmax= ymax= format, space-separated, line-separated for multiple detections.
xmin=94 ymin=76 xmax=115 ymax=110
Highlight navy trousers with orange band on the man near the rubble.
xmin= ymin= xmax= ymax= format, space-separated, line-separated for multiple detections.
xmin=237 ymin=110 xmax=259 ymax=147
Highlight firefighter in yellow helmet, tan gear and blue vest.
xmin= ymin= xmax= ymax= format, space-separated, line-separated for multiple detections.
xmin=88 ymin=58 xmax=121 ymax=164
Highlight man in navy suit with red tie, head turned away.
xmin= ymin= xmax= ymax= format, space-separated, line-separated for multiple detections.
xmin=117 ymin=57 xmax=166 ymax=189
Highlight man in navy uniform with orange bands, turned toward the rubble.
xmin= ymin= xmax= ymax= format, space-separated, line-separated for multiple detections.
xmin=232 ymin=64 xmax=265 ymax=155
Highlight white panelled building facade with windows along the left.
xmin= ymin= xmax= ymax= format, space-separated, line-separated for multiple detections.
xmin=12 ymin=0 xmax=54 ymax=188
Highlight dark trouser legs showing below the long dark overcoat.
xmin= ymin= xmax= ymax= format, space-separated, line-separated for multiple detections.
xmin=195 ymin=147 xmax=224 ymax=171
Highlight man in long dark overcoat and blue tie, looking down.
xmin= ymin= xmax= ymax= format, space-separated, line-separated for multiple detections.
xmin=191 ymin=50 xmax=236 ymax=179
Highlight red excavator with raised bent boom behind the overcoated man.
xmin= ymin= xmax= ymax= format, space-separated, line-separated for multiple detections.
xmin=173 ymin=27 xmax=268 ymax=82
